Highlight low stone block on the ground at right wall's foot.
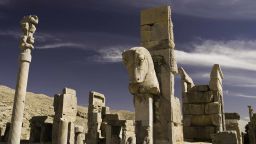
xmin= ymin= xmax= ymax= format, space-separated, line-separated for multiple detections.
xmin=212 ymin=131 xmax=239 ymax=144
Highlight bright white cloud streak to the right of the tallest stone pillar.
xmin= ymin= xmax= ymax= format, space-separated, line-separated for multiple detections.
xmin=176 ymin=40 xmax=256 ymax=71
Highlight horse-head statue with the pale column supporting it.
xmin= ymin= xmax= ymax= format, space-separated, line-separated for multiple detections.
xmin=122 ymin=47 xmax=160 ymax=144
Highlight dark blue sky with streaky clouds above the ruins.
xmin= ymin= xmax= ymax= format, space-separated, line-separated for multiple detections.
xmin=0 ymin=0 xmax=256 ymax=127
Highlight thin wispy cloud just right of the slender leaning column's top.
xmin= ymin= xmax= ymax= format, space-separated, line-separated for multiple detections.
xmin=36 ymin=43 xmax=86 ymax=49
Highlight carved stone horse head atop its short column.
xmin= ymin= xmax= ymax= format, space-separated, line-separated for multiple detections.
xmin=122 ymin=47 xmax=160 ymax=95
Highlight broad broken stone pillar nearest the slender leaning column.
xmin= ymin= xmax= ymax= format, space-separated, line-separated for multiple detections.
xmin=52 ymin=88 xmax=77 ymax=144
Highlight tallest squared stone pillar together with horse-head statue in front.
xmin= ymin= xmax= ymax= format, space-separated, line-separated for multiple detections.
xmin=122 ymin=7 xmax=183 ymax=144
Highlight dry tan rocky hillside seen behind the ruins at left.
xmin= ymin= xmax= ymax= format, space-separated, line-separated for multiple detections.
xmin=0 ymin=85 xmax=134 ymax=143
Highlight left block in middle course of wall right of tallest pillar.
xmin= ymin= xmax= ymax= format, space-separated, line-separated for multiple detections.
xmin=183 ymin=104 xmax=205 ymax=115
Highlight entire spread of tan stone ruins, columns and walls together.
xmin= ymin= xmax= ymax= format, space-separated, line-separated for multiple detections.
xmin=0 ymin=6 xmax=256 ymax=144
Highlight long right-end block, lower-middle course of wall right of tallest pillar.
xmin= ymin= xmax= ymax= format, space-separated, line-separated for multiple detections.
xmin=191 ymin=114 xmax=221 ymax=126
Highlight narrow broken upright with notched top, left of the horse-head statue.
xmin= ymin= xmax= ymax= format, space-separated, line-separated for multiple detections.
xmin=86 ymin=91 xmax=108 ymax=144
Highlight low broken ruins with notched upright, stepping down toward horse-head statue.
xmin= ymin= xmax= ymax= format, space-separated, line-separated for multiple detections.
xmin=86 ymin=91 xmax=135 ymax=144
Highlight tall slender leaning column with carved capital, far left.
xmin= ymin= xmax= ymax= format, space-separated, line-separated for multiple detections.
xmin=8 ymin=15 xmax=38 ymax=144
